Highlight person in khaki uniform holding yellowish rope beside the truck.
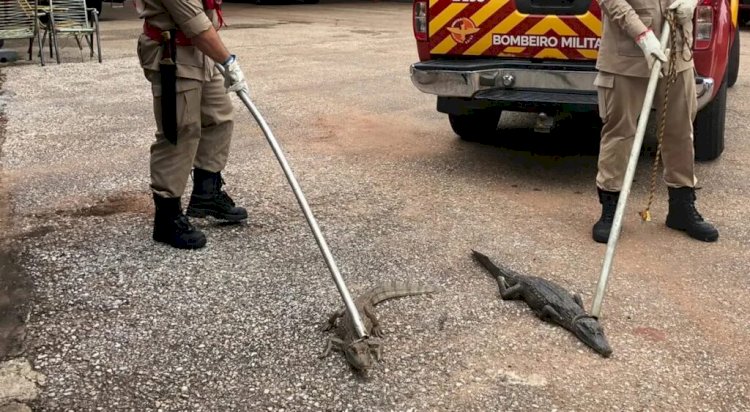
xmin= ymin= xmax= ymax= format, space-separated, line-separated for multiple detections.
xmin=592 ymin=0 xmax=719 ymax=243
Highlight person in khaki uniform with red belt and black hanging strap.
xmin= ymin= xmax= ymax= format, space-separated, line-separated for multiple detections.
xmin=136 ymin=0 xmax=247 ymax=249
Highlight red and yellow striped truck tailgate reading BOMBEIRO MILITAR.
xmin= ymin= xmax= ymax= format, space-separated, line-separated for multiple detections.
xmin=428 ymin=0 xmax=601 ymax=60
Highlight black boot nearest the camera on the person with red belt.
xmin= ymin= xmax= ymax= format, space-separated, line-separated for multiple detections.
xmin=153 ymin=193 xmax=206 ymax=249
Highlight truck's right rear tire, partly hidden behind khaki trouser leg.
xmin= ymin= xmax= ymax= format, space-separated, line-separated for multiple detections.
xmin=693 ymin=76 xmax=728 ymax=161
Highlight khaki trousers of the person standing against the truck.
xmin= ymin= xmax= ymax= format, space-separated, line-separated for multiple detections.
xmin=595 ymin=70 xmax=698 ymax=192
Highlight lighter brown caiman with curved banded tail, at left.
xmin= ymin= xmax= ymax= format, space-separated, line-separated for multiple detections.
xmin=321 ymin=281 xmax=439 ymax=373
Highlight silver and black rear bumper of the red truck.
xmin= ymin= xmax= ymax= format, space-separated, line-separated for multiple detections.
xmin=410 ymin=60 xmax=714 ymax=110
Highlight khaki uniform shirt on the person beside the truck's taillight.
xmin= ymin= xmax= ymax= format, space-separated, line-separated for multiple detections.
xmin=596 ymin=0 xmax=693 ymax=77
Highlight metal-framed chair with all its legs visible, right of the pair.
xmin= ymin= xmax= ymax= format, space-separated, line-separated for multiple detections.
xmin=41 ymin=0 xmax=102 ymax=63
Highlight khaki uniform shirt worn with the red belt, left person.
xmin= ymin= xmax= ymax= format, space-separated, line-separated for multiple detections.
xmin=138 ymin=0 xmax=219 ymax=84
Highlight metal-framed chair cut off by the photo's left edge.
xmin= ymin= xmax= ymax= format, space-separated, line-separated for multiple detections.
xmin=0 ymin=0 xmax=44 ymax=65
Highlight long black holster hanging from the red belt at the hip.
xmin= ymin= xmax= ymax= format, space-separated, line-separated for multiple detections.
xmin=159 ymin=30 xmax=177 ymax=145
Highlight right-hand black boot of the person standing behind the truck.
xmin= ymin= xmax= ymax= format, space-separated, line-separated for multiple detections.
xmin=667 ymin=187 xmax=719 ymax=242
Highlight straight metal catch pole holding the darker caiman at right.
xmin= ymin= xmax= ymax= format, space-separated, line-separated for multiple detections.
xmin=591 ymin=19 xmax=671 ymax=317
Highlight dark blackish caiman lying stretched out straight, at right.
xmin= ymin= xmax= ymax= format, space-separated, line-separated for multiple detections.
xmin=472 ymin=250 xmax=612 ymax=358
